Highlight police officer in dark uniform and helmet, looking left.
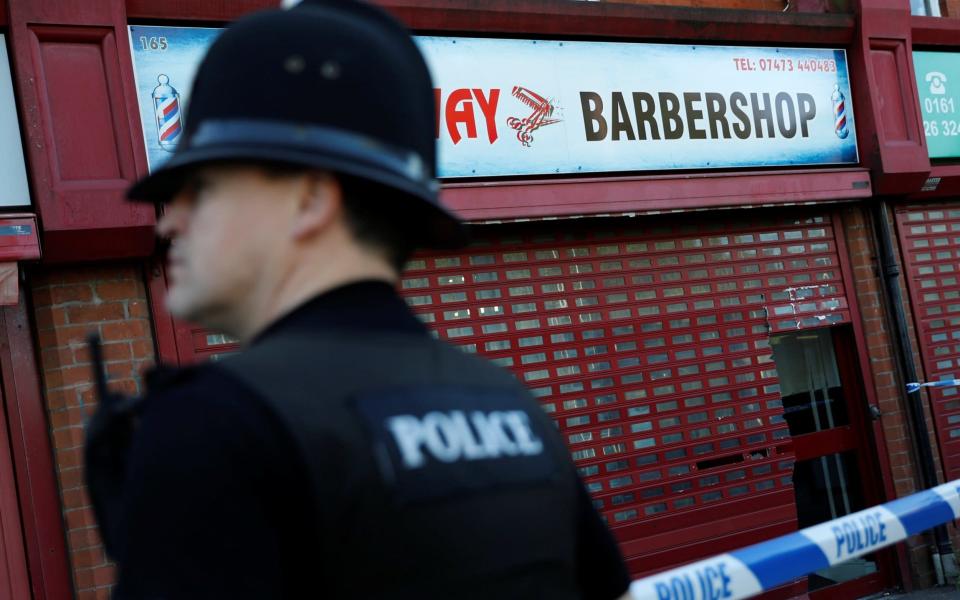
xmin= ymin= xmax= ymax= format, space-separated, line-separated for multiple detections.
xmin=88 ymin=0 xmax=629 ymax=600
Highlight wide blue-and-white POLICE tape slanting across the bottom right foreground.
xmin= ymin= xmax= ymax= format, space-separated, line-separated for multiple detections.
xmin=630 ymin=479 xmax=960 ymax=600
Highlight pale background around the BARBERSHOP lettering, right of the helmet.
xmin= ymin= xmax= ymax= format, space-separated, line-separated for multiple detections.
xmin=417 ymin=37 xmax=858 ymax=177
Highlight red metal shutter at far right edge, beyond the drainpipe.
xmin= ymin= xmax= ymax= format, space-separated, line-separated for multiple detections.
xmin=897 ymin=206 xmax=960 ymax=480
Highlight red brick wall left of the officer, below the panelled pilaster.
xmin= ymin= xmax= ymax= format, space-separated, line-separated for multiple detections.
xmin=30 ymin=265 xmax=154 ymax=600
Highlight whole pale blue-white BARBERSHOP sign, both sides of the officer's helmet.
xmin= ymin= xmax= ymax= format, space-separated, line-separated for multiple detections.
xmin=130 ymin=26 xmax=858 ymax=178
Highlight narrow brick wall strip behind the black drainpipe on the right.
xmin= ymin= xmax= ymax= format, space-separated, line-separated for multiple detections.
xmin=842 ymin=206 xmax=942 ymax=587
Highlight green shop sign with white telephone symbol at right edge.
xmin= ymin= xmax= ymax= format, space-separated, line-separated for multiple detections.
xmin=913 ymin=52 xmax=960 ymax=158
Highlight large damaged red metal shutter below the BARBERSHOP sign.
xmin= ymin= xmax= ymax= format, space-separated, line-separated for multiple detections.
xmin=401 ymin=213 xmax=850 ymax=573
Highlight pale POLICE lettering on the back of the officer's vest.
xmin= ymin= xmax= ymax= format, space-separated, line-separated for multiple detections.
xmin=385 ymin=410 xmax=543 ymax=469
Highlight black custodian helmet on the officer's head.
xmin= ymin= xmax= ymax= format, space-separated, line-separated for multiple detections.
xmin=127 ymin=0 xmax=464 ymax=247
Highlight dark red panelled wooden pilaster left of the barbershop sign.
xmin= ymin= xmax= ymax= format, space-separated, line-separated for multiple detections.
xmin=9 ymin=0 xmax=156 ymax=260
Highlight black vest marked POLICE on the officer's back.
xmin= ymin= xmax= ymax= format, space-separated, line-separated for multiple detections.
xmin=221 ymin=332 xmax=582 ymax=600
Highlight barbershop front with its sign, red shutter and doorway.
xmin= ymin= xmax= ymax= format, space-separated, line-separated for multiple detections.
xmin=129 ymin=12 xmax=893 ymax=595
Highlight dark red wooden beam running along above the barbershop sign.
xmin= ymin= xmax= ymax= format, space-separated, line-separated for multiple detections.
xmin=127 ymin=0 xmax=855 ymax=47
